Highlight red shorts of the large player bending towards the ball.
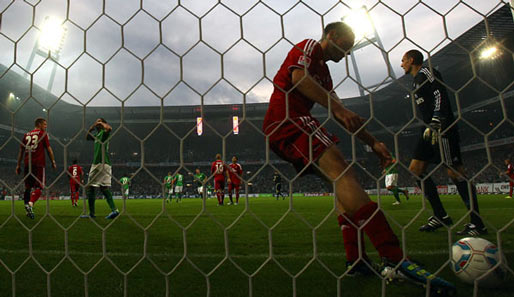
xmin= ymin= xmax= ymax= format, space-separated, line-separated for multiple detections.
xmin=263 ymin=116 xmax=339 ymax=174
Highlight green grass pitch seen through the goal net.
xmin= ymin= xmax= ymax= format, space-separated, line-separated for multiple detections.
xmin=0 ymin=195 xmax=514 ymax=297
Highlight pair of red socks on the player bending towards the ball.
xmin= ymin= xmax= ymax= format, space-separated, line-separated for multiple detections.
xmin=338 ymin=202 xmax=403 ymax=263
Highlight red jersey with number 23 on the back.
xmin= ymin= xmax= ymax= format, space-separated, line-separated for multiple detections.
xmin=20 ymin=129 xmax=50 ymax=167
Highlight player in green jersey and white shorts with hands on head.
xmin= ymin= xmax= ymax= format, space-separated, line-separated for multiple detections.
xmin=82 ymin=118 xmax=120 ymax=219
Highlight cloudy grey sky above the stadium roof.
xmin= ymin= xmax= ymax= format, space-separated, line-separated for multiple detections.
xmin=0 ymin=0 xmax=505 ymax=106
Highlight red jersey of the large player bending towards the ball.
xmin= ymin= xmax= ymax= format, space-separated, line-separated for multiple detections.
xmin=264 ymin=39 xmax=332 ymax=127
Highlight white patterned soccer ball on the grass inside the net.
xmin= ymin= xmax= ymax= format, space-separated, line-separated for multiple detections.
xmin=452 ymin=237 xmax=507 ymax=288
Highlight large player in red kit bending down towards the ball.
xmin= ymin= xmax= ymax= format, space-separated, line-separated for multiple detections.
xmin=263 ymin=22 xmax=455 ymax=294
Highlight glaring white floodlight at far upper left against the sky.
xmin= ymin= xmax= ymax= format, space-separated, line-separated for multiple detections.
xmin=38 ymin=16 xmax=66 ymax=54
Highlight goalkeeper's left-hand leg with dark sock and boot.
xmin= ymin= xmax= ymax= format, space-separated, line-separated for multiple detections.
xmin=409 ymin=159 xmax=453 ymax=232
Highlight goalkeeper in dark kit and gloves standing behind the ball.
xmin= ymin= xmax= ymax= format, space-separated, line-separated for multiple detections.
xmin=401 ymin=50 xmax=487 ymax=236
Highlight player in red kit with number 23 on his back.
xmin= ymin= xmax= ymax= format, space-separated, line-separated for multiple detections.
xmin=16 ymin=118 xmax=57 ymax=219
